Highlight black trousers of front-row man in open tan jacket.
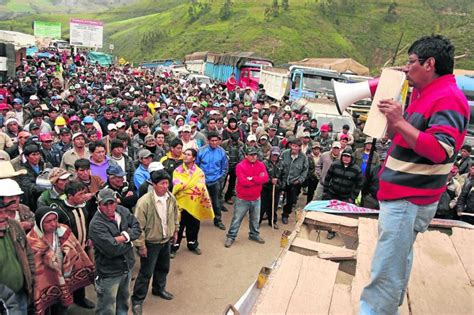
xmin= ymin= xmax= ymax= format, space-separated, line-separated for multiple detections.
xmin=132 ymin=241 xmax=170 ymax=305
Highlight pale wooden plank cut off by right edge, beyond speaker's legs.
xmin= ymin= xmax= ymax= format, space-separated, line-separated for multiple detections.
xmin=451 ymin=228 xmax=474 ymax=286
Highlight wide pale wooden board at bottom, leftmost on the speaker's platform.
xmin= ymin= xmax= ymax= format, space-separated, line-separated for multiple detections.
xmin=253 ymin=251 xmax=338 ymax=314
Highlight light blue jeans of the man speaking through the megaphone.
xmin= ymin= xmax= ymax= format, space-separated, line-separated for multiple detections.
xmin=359 ymin=199 xmax=438 ymax=315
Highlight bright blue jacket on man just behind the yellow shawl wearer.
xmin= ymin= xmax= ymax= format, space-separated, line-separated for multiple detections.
xmin=196 ymin=145 xmax=228 ymax=184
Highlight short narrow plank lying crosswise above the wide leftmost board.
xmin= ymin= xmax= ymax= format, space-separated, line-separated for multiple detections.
xmin=290 ymin=237 xmax=356 ymax=261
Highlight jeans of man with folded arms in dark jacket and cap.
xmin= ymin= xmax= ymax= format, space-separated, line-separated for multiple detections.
xmin=95 ymin=272 xmax=132 ymax=315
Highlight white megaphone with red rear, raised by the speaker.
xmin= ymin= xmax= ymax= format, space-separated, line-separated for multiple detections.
xmin=331 ymin=78 xmax=379 ymax=115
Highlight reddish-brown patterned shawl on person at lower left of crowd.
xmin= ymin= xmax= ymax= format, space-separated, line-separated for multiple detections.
xmin=27 ymin=224 xmax=94 ymax=315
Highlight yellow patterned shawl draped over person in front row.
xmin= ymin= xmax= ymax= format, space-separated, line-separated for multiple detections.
xmin=173 ymin=164 xmax=214 ymax=221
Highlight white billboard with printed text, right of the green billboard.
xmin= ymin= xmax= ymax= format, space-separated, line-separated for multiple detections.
xmin=69 ymin=19 xmax=104 ymax=48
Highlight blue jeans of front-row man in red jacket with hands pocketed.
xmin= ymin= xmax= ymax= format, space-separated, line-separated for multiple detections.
xmin=227 ymin=197 xmax=260 ymax=240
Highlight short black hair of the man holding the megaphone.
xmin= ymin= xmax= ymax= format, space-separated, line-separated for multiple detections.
xmin=408 ymin=35 xmax=454 ymax=76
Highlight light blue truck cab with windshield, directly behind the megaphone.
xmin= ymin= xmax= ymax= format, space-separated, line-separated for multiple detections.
xmin=290 ymin=66 xmax=346 ymax=101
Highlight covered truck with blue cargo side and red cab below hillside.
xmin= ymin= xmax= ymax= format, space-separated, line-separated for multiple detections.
xmin=204 ymin=52 xmax=273 ymax=91
